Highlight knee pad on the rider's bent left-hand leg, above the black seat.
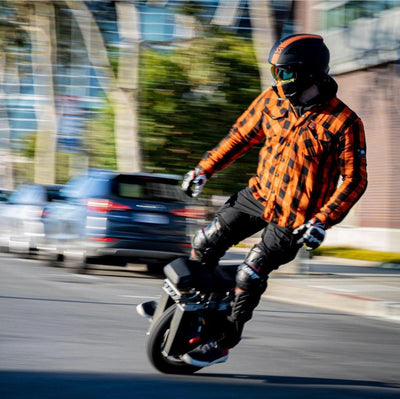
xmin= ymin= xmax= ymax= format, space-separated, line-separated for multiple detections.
xmin=192 ymin=218 xmax=229 ymax=263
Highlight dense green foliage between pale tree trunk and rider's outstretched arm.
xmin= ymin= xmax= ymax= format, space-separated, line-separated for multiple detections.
xmin=139 ymin=28 xmax=260 ymax=194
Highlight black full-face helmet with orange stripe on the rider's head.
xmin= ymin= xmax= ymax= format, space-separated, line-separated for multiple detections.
xmin=268 ymin=33 xmax=329 ymax=102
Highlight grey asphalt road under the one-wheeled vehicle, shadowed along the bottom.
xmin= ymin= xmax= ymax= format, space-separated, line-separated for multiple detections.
xmin=0 ymin=254 xmax=400 ymax=399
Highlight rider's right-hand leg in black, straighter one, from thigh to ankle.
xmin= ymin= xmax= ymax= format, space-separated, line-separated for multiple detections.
xmin=223 ymin=223 xmax=299 ymax=348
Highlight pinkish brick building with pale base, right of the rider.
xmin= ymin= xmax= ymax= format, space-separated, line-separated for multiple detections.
xmin=296 ymin=0 xmax=400 ymax=252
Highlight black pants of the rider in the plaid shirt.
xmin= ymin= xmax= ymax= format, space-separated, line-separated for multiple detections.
xmin=198 ymin=188 xmax=300 ymax=347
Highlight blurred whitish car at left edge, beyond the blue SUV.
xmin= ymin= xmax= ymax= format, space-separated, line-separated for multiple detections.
xmin=0 ymin=184 xmax=63 ymax=253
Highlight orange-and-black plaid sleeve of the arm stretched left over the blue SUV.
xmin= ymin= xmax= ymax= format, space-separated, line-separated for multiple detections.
xmin=198 ymin=91 xmax=268 ymax=176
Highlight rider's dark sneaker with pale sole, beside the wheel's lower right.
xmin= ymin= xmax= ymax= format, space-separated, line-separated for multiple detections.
xmin=181 ymin=339 xmax=229 ymax=367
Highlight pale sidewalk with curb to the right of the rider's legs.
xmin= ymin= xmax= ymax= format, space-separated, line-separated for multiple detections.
xmin=228 ymin=242 xmax=400 ymax=323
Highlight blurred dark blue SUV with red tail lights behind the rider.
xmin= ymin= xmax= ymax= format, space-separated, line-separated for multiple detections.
xmin=43 ymin=170 xmax=204 ymax=271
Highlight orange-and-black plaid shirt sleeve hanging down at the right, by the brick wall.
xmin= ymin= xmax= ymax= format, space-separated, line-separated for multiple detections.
xmin=315 ymin=118 xmax=367 ymax=227
